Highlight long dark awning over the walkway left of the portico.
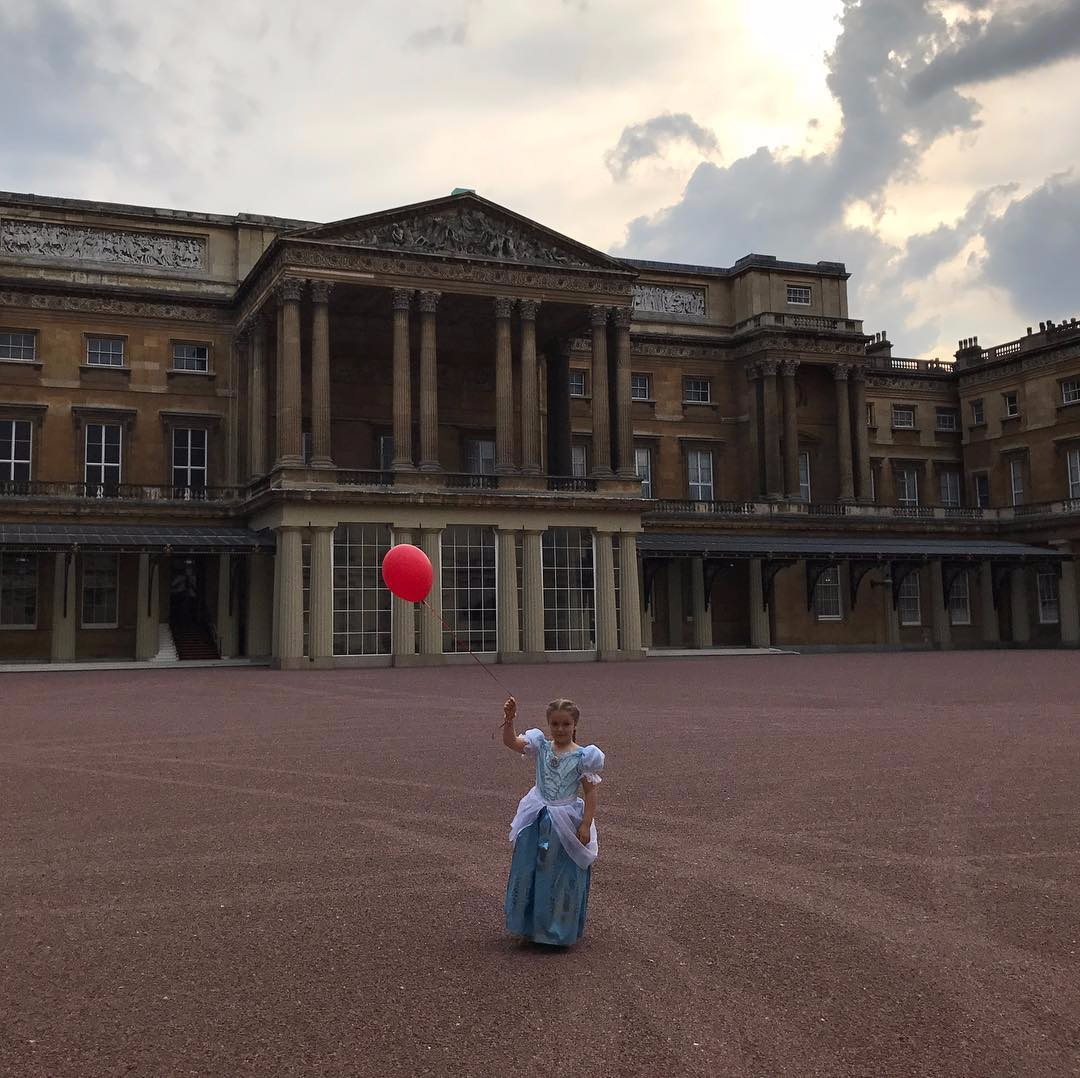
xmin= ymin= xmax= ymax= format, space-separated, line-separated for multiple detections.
xmin=0 ymin=523 xmax=274 ymax=554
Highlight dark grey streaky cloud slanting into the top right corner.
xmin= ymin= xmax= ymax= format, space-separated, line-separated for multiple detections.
xmin=907 ymin=0 xmax=1080 ymax=102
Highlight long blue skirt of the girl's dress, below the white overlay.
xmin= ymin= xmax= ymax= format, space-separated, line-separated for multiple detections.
xmin=505 ymin=809 xmax=592 ymax=947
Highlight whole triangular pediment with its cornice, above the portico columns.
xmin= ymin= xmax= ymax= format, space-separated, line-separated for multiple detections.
xmin=289 ymin=192 xmax=629 ymax=272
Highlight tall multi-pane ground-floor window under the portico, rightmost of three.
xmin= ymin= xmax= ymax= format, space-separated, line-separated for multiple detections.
xmin=543 ymin=528 xmax=596 ymax=651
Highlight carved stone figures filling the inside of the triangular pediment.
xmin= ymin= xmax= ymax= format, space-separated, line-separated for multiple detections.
xmin=320 ymin=206 xmax=593 ymax=269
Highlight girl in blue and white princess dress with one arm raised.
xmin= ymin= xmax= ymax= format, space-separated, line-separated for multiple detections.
xmin=502 ymin=697 xmax=604 ymax=947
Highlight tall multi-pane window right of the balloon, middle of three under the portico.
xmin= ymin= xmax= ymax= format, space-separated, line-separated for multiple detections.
xmin=443 ymin=525 xmax=498 ymax=652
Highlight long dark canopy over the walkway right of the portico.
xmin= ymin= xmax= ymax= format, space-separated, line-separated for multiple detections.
xmin=637 ymin=531 xmax=1072 ymax=562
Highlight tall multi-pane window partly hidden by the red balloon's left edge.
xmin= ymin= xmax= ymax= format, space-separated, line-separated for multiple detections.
xmin=334 ymin=524 xmax=390 ymax=655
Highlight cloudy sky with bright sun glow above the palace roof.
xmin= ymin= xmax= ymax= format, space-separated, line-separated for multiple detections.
xmin=0 ymin=0 xmax=1080 ymax=358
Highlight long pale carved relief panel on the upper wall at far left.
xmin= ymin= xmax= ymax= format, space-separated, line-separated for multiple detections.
xmin=0 ymin=217 xmax=206 ymax=271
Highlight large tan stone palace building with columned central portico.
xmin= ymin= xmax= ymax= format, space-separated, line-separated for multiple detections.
xmin=0 ymin=190 xmax=1080 ymax=669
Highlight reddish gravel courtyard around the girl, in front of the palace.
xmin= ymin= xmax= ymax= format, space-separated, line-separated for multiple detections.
xmin=0 ymin=651 xmax=1080 ymax=1078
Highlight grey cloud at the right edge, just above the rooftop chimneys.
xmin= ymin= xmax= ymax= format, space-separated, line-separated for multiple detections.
xmin=982 ymin=171 xmax=1080 ymax=321
